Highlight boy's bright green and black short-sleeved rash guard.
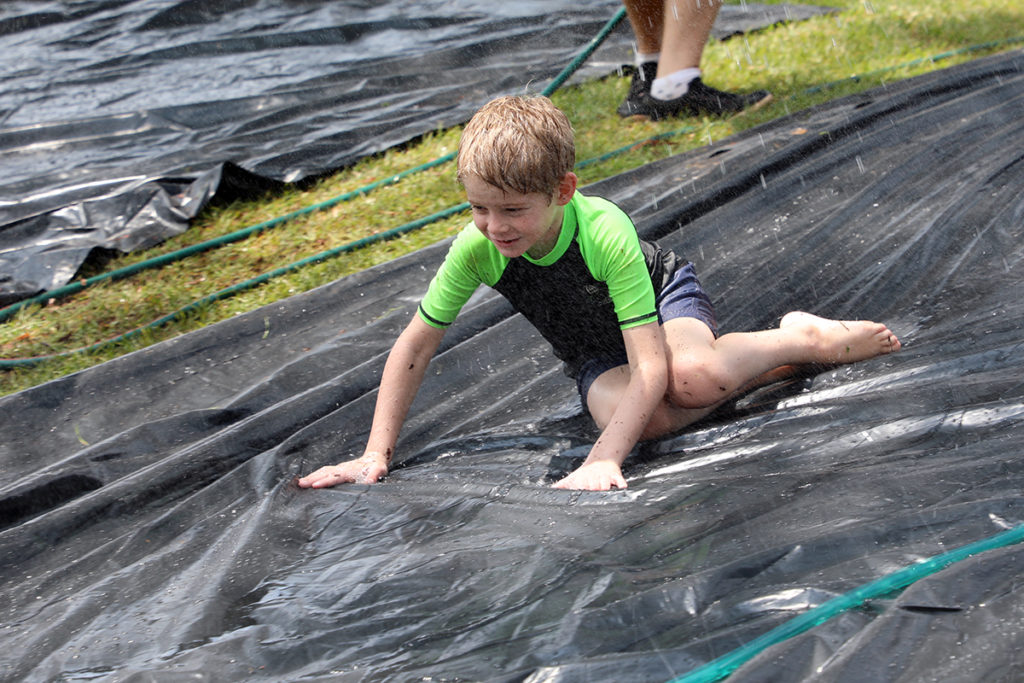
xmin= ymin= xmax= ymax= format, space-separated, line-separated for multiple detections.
xmin=419 ymin=193 xmax=677 ymax=378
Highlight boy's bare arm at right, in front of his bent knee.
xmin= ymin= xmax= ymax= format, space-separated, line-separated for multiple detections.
xmin=555 ymin=323 xmax=669 ymax=490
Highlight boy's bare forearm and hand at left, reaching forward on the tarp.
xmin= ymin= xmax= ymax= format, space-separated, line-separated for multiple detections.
xmin=298 ymin=315 xmax=444 ymax=488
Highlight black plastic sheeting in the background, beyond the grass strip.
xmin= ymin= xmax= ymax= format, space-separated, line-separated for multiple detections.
xmin=0 ymin=0 xmax=824 ymax=305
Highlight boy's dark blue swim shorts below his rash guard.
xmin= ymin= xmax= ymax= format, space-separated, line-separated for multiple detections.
xmin=577 ymin=262 xmax=718 ymax=413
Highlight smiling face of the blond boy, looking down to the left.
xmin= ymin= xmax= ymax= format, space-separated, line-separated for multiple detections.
xmin=463 ymin=173 xmax=577 ymax=258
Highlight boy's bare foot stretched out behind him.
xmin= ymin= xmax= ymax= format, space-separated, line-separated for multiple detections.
xmin=778 ymin=310 xmax=901 ymax=364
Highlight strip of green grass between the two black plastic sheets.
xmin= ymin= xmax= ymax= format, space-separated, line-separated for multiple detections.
xmin=0 ymin=0 xmax=1024 ymax=395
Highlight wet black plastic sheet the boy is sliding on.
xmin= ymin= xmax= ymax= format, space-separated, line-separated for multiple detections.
xmin=0 ymin=51 xmax=1024 ymax=682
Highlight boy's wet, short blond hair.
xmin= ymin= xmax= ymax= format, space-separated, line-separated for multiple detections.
xmin=457 ymin=96 xmax=575 ymax=196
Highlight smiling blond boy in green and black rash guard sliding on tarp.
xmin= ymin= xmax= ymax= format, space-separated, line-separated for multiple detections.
xmin=298 ymin=97 xmax=900 ymax=490
